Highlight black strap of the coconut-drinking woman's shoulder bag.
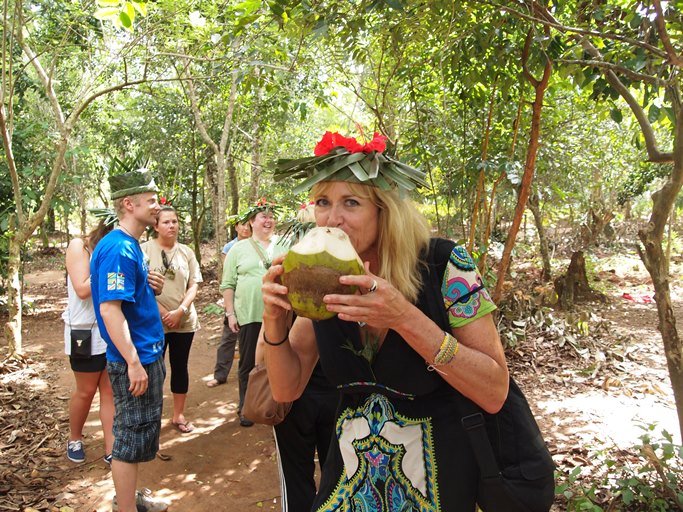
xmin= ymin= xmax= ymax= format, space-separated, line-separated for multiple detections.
xmin=425 ymin=238 xmax=500 ymax=478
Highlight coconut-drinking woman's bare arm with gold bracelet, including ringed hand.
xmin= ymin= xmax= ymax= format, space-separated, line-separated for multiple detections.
xmin=324 ymin=273 xmax=509 ymax=413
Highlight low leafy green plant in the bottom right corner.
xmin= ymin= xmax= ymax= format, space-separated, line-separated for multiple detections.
xmin=555 ymin=424 xmax=683 ymax=512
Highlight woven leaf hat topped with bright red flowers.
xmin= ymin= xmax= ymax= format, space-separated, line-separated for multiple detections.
xmin=274 ymin=132 xmax=429 ymax=194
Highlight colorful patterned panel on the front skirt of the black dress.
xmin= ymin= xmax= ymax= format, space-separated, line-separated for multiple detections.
xmin=318 ymin=393 xmax=441 ymax=512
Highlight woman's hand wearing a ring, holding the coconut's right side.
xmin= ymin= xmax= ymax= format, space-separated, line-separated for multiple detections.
xmin=323 ymin=261 xmax=411 ymax=329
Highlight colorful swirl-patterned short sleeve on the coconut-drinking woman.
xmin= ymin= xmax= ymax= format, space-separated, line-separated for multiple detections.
xmin=441 ymin=245 xmax=496 ymax=327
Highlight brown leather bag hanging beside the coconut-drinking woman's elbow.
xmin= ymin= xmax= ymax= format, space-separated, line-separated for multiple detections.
xmin=242 ymin=363 xmax=292 ymax=426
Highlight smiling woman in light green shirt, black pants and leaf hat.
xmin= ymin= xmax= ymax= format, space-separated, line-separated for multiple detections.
xmin=220 ymin=198 xmax=287 ymax=427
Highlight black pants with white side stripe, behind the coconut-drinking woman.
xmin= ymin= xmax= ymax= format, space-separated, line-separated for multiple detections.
xmin=274 ymin=384 xmax=339 ymax=512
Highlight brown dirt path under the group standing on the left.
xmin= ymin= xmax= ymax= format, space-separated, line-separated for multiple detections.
xmin=17 ymin=272 xmax=280 ymax=512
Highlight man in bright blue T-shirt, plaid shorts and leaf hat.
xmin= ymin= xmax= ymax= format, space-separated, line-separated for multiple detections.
xmin=90 ymin=169 xmax=168 ymax=512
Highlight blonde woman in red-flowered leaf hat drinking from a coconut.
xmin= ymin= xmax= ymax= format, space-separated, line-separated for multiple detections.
xmin=262 ymin=132 xmax=508 ymax=512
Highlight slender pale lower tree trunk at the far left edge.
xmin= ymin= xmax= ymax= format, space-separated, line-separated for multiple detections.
xmin=5 ymin=215 xmax=24 ymax=358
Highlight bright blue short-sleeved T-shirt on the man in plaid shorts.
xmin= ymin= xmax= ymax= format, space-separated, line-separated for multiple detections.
xmin=90 ymin=229 xmax=164 ymax=365
